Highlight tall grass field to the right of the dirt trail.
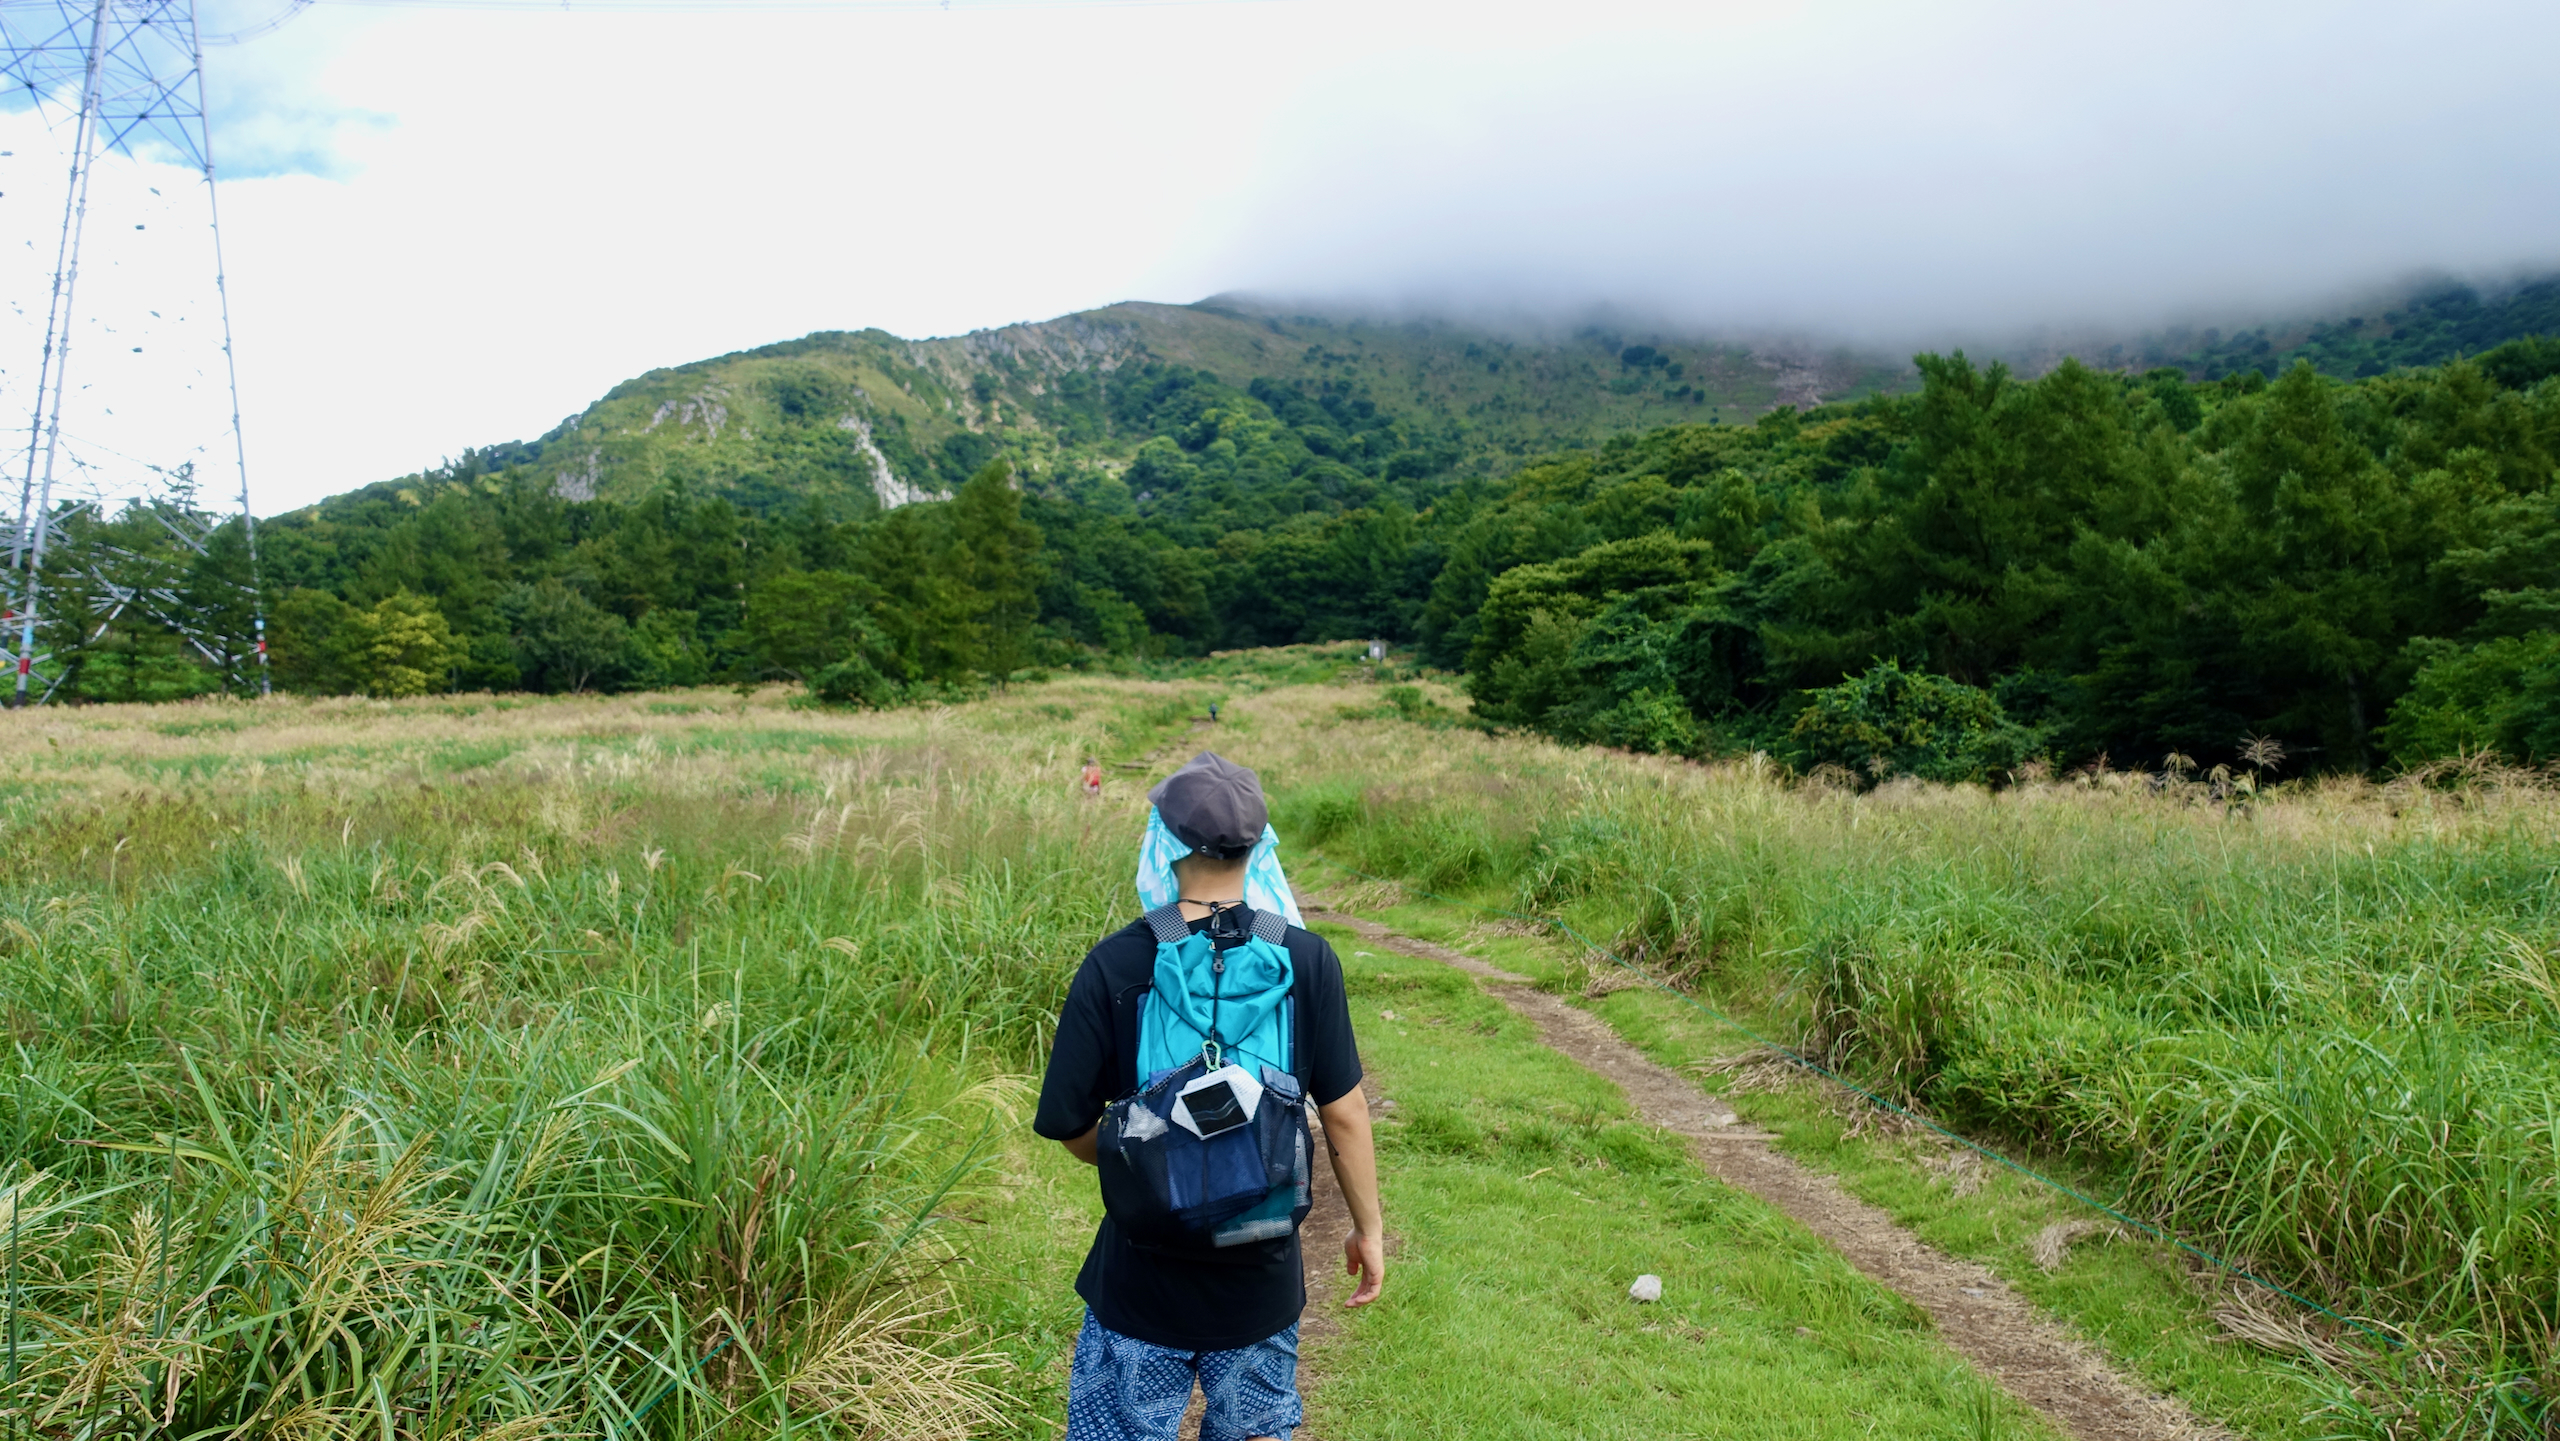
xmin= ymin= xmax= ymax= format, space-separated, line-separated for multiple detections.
xmin=1295 ymin=752 xmax=2560 ymax=1436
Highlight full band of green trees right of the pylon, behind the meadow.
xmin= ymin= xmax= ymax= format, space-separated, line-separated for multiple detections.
xmin=45 ymin=340 xmax=2560 ymax=776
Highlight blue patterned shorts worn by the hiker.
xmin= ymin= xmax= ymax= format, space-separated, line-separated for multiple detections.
xmin=1068 ymin=1308 xmax=1300 ymax=1441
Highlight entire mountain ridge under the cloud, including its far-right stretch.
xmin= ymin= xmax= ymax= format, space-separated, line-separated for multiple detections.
xmin=317 ymin=276 xmax=2560 ymax=527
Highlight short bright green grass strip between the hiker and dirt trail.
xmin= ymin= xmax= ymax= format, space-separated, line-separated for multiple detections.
xmin=1311 ymin=927 xmax=2048 ymax=1438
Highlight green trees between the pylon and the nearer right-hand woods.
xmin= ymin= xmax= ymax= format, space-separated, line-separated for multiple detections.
xmin=204 ymin=366 xmax=1454 ymax=701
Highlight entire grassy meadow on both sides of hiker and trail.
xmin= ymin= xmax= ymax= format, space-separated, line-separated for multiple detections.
xmin=0 ymin=653 xmax=2560 ymax=1438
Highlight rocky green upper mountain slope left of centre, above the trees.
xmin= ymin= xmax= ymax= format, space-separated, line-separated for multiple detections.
xmin=409 ymin=299 xmax=1907 ymax=514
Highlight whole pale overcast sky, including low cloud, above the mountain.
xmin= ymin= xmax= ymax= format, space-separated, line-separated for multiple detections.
xmin=0 ymin=0 xmax=2560 ymax=512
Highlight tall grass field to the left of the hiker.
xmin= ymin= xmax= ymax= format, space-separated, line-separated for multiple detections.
xmin=0 ymin=699 xmax=1147 ymax=1438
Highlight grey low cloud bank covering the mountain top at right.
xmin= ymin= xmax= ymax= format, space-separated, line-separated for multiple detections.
xmin=1167 ymin=3 xmax=2560 ymax=346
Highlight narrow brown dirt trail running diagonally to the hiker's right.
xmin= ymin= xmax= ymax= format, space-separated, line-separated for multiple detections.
xmin=1300 ymin=893 xmax=2237 ymax=1441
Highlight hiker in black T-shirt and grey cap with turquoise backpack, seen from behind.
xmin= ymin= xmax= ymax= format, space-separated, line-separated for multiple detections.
xmin=1032 ymin=752 xmax=1385 ymax=1441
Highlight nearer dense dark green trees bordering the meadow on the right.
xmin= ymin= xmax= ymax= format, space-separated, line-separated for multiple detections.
xmin=1421 ymin=343 xmax=2560 ymax=773
